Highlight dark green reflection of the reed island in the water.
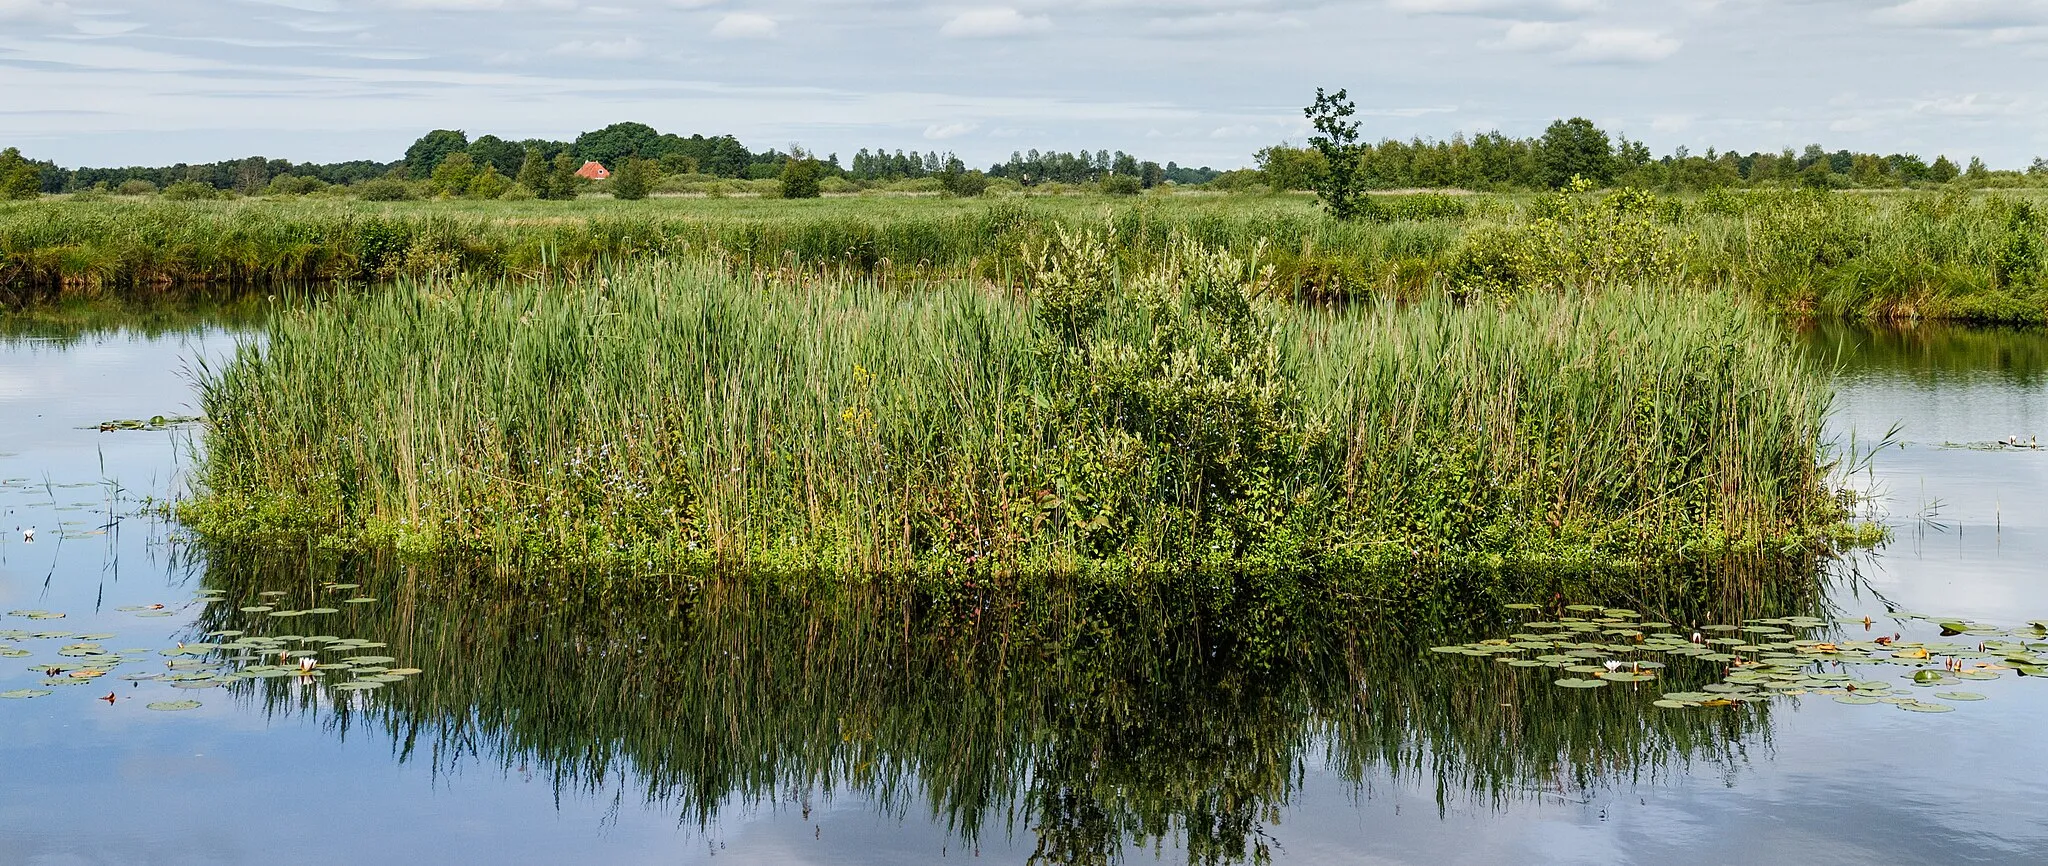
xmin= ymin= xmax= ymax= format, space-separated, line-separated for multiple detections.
xmin=199 ymin=553 xmax=1819 ymax=862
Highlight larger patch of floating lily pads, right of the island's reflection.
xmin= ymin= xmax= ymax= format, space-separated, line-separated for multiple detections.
xmin=1432 ymin=604 xmax=2048 ymax=712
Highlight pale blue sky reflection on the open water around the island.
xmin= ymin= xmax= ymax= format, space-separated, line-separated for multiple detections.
xmin=0 ymin=323 xmax=2048 ymax=866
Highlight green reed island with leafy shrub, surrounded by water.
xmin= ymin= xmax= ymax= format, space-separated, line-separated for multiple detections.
xmin=180 ymin=233 xmax=1839 ymax=579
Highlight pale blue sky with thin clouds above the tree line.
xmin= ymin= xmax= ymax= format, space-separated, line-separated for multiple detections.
xmin=0 ymin=0 xmax=2048 ymax=168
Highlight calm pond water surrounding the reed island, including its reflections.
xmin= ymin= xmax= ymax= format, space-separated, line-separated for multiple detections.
xmin=0 ymin=328 xmax=2048 ymax=866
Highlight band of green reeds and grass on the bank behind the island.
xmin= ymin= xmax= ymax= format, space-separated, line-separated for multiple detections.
xmin=12 ymin=190 xmax=2048 ymax=323
